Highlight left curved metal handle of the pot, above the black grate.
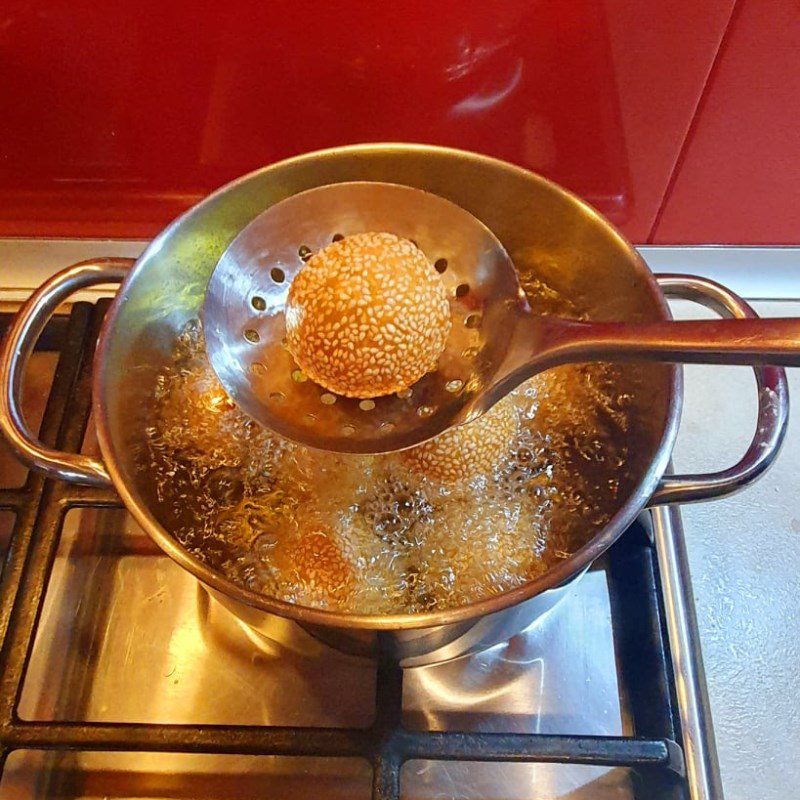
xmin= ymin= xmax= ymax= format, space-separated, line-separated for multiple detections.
xmin=0 ymin=258 xmax=135 ymax=486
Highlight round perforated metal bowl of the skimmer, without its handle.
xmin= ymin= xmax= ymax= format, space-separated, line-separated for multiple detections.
xmin=202 ymin=182 xmax=525 ymax=453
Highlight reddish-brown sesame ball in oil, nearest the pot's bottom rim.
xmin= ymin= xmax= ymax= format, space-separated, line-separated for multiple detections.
xmin=275 ymin=526 xmax=355 ymax=606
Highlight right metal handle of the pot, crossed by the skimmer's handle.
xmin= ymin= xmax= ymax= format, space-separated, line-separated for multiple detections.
xmin=648 ymin=274 xmax=789 ymax=506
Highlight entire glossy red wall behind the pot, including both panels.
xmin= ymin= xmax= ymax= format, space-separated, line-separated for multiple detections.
xmin=0 ymin=0 xmax=800 ymax=243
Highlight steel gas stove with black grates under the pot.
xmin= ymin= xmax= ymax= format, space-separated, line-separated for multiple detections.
xmin=0 ymin=244 xmax=721 ymax=800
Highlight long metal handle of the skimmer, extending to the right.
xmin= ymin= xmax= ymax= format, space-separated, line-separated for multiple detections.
xmin=532 ymin=317 xmax=800 ymax=367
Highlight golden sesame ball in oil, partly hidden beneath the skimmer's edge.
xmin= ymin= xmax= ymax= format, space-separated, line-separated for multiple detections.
xmin=402 ymin=397 xmax=519 ymax=485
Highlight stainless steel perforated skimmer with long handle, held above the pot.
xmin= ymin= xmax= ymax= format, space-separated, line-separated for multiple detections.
xmin=203 ymin=182 xmax=800 ymax=453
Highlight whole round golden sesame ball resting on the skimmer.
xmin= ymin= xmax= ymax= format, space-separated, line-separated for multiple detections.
xmin=286 ymin=233 xmax=450 ymax=398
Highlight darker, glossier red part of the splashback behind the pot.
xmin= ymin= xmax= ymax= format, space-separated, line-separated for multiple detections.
xmin=0 ymin=0 xmax=631 ymax=236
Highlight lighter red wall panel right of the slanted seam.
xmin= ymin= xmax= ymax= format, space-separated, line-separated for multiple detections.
xmin=654 ymin=0 xmax=800 ymax=244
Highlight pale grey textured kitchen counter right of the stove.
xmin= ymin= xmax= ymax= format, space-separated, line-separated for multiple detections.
xmin=674 ymin=302 xmax=800 ymax=800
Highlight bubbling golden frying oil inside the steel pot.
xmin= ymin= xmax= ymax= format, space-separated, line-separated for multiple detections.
xmin=142 ymin=281 xmax=635 ymax=614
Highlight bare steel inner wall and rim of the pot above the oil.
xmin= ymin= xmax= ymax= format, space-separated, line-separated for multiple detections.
xmin=95 ymin=145 xmax=676 ymax=623
